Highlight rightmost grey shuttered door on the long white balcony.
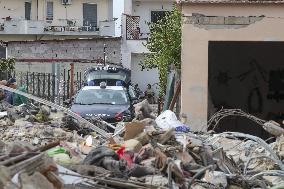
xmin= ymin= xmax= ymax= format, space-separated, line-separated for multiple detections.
xmin=83 ymin=3 xmax=97 ymax=31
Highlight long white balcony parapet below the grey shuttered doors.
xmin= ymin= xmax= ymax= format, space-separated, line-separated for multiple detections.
xmin=0 ymin=19 xmax=115 ymax=37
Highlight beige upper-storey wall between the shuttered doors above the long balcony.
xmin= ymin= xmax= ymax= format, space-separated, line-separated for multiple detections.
xmin=0 ymin=0 xmax=111 ymax=25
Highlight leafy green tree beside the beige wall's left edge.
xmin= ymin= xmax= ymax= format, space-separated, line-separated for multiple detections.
xmin=140 ymin=7 xmax=181 ymax=96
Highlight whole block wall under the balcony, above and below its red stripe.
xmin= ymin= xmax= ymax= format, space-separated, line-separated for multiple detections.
xmin=8 ymin=38 xmax=121 ymax=72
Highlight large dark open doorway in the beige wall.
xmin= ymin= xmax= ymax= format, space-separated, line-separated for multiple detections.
xmin=208 ymin=41 xmax=284 ymax=138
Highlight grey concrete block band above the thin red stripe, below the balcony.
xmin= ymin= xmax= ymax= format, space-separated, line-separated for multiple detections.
xmin=8 ymin=38 xmax=120 ymax=64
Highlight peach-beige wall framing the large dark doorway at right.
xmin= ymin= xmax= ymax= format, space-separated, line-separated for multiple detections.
xmin=181 ymin=4 xmax=284 ymax=130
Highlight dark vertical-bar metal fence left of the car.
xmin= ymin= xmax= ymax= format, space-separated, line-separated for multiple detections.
xmin=0 ymin=69 xmax=84 ymax=104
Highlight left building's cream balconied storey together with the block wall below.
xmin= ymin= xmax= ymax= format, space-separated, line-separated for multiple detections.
xmin=0 ymin=0 xmax=123 ymax=72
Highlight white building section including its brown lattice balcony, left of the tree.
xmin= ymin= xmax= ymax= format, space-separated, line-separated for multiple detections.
xmin=121 ymin=0 xmax=174 ymax=94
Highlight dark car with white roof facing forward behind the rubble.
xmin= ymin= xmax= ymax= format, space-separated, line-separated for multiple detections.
xmin=71 ymin=84 xmax=134 ymax=124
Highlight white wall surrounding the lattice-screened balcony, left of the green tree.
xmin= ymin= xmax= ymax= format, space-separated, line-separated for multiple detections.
xmin=121 ymin=0 xmax=174 ymax=99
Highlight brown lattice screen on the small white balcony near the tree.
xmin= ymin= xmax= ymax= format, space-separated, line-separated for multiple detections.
xmin=126 ymin=15 xmax=149 ymax=40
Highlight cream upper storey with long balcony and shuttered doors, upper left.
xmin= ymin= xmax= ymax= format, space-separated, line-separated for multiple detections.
xmin=0 ymin=0 xmax=120 ymax=40
